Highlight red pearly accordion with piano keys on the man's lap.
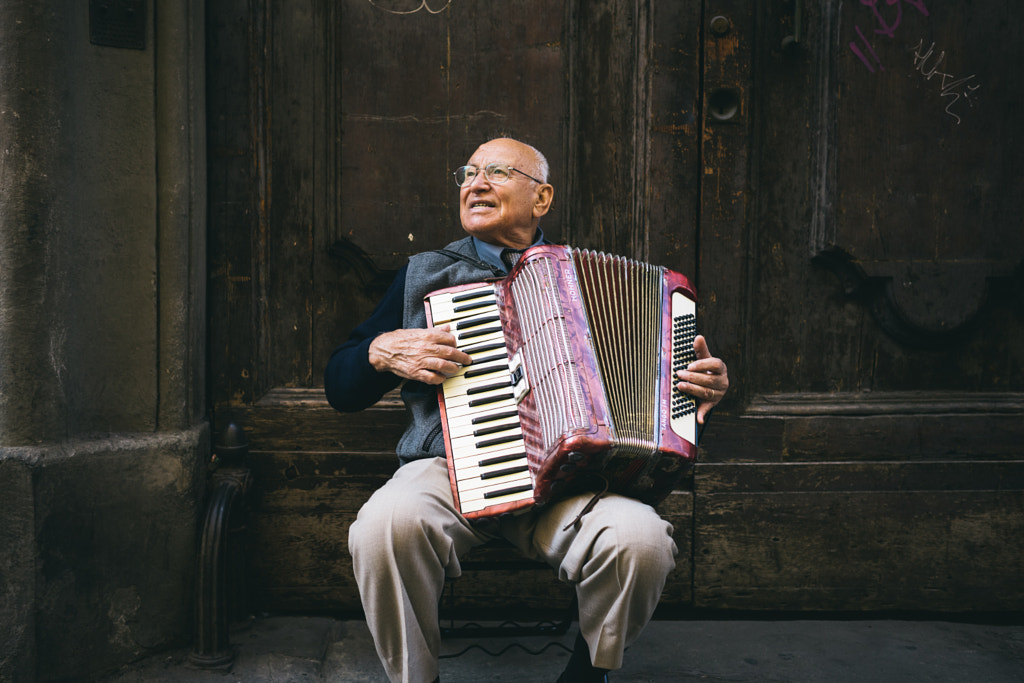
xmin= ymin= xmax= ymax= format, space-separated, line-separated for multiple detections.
xmin=425 ymin=245 xmax=697 ymax=518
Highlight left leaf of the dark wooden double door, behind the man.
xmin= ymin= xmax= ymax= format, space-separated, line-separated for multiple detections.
xmin=208 ymin=0 xmax=698 ymax=609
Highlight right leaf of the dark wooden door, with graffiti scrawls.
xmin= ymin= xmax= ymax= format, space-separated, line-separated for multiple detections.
xmin=693 ymin=0 xmax=1024 ymax=611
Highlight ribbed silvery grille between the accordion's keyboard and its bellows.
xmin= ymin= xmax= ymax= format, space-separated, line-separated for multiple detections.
xmin=511 ymin=257 xmax=589 ymax=451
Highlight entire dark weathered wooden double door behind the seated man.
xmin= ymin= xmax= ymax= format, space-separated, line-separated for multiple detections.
xmin=207 ymin=0 xmax=1024 ymax=609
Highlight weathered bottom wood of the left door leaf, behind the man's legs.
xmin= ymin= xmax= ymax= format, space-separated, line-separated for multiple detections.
xmin=233 ymin=391 xmax=693 ymax=616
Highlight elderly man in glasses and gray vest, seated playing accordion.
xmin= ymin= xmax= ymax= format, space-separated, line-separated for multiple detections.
xmin=324 ymin=138 xmax=729 ymax=683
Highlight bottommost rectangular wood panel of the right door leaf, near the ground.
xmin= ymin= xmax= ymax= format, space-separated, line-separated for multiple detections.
xmin=694 ymin=461 xmax=1024 ymax=611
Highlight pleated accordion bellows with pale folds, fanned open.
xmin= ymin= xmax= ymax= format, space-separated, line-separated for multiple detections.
xmin=573 ymin=250 xmax=663 ymax=454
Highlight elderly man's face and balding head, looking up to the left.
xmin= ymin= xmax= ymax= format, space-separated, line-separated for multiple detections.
xmin=459 ymin=139 xmax=553 ymax=249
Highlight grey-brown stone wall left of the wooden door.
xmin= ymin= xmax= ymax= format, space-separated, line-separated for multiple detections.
xmin=0 ymin=0 xmax=210 ymax=681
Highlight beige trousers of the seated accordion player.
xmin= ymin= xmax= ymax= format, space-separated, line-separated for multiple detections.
xmin=348 ymin=458 xmax=676 ymax=683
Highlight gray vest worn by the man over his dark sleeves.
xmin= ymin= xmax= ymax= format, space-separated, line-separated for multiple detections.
xmin=397 ymin=238 xmax=501 ymax=465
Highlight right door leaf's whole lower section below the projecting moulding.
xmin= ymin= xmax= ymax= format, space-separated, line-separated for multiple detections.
xmin=693 ymin=405 xmax=1024 ymax=611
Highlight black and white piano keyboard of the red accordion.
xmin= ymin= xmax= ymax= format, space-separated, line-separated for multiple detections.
xmin=428 ymin=285 xmax=534 ymax=514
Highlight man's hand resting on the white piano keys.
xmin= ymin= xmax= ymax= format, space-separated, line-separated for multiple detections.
xmin=370 ymin=326 xmax=473 ymax=384
